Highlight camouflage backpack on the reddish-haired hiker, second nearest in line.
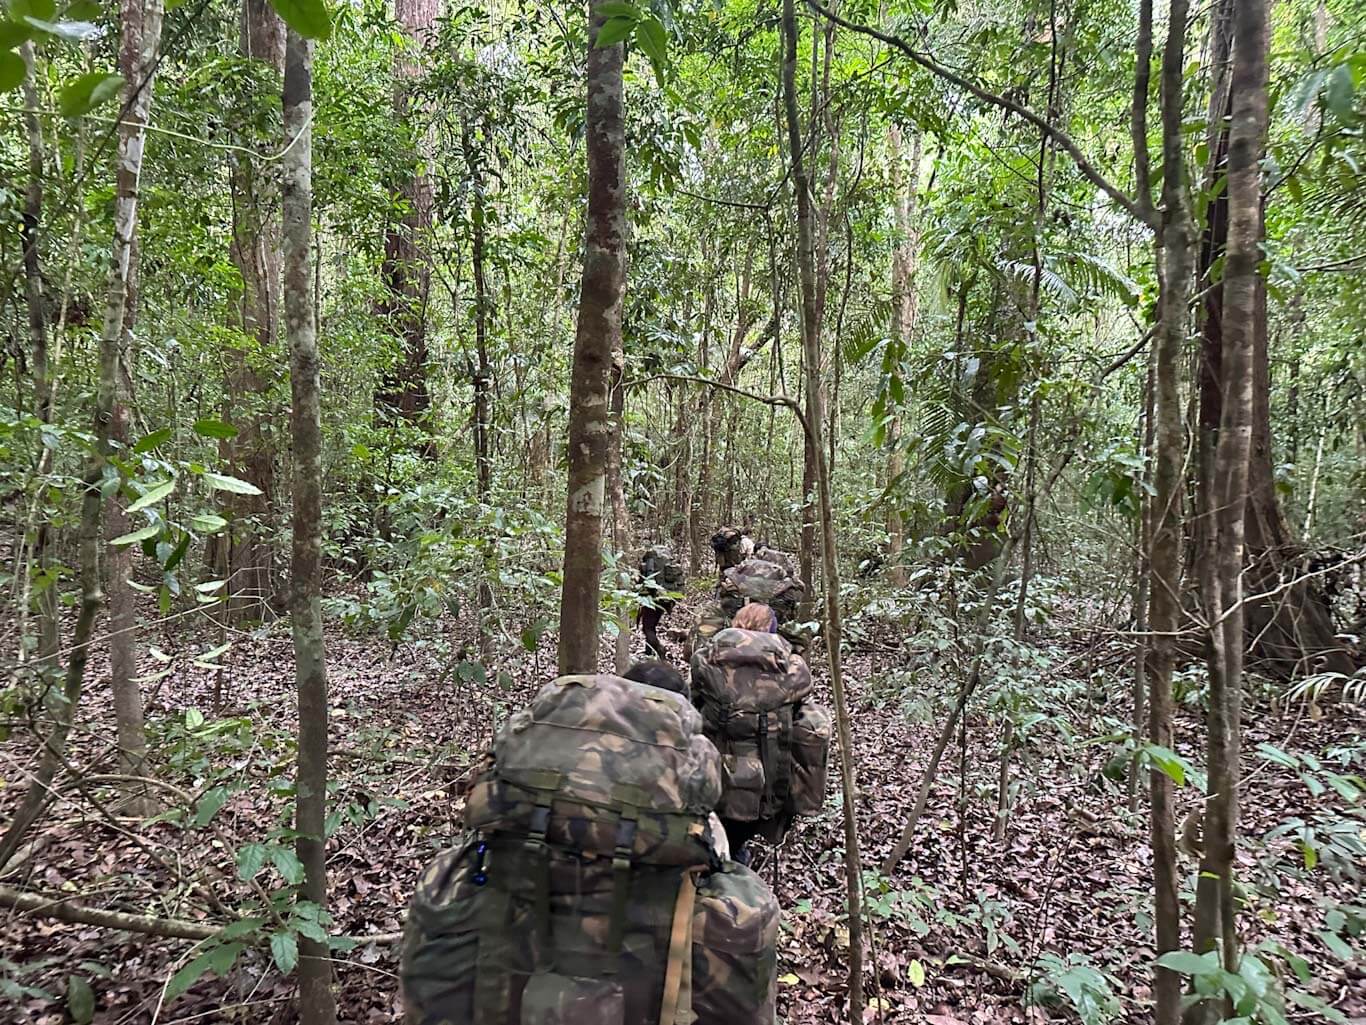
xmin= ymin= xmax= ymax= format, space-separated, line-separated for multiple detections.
xmin=693 ymin=627 xmax=831 ymax=839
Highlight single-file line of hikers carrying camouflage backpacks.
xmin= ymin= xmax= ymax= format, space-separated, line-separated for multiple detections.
xmin=402 ymin=529 xmax=831 ymax=1025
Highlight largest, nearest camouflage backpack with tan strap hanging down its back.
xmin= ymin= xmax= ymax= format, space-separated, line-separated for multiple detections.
xmin=400 ymin=675 xmax=777 ymax=1025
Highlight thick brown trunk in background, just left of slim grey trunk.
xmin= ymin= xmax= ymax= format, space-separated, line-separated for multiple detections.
xmin=214 ymin=0 xmax=284 ymax=619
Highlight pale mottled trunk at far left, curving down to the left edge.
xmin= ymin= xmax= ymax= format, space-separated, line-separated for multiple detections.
xmin=0 ymin=0 xmax=163 ymax=869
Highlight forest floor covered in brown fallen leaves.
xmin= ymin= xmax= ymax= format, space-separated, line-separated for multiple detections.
xmin=0 ymin=590 xmax=1366 ymax=1025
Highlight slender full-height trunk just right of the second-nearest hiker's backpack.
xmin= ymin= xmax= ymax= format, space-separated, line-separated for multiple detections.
xmin=783 ymin=0 xmax=863 ymax=1025
